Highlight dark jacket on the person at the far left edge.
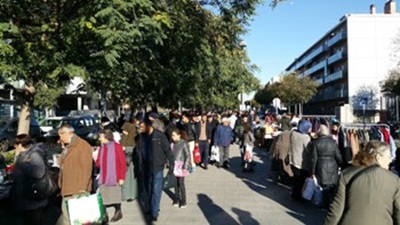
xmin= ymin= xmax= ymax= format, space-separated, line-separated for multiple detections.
xmin=10 ymin=145 xmax=48 ymax=211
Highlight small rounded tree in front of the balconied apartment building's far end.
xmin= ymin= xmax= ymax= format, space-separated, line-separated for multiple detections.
xmin=270 ymin=73 xmax=318 ymax=105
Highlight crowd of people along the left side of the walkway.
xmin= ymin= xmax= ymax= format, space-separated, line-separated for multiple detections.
xmin=4 ymin=108 xmax=255 ymax=225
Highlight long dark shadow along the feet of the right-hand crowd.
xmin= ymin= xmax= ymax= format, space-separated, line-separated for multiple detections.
xmin=228 ymin=149 xmax=325 ymax=224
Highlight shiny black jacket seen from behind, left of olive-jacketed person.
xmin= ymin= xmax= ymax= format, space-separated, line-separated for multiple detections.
xmin=311 ymin=136 xmax=342 ymax=185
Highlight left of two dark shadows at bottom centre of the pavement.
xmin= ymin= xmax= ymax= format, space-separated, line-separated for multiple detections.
xmin=197 ymin=194 xmax=240 ymax=225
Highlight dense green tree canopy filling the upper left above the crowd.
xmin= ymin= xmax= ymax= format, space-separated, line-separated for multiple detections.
xmin=0 ymin=0 xmax=280 ymax=112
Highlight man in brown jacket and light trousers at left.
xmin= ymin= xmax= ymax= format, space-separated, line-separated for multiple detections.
xmin=57 ymin=124 xmax=93 ymax=225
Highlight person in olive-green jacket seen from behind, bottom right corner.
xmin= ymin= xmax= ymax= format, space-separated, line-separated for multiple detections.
xmin=323 ymin=141 xmax=400 ymax=225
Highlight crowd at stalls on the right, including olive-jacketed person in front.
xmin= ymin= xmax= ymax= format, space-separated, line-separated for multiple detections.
xmin=264 ymin=115 xmax=400 ymax=225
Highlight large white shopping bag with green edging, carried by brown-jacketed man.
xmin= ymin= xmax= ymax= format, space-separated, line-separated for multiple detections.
xmin=67 ymin=193 xmax=104 ymax=225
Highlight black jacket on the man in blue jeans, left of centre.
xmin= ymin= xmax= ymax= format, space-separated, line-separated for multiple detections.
xmin=141 ymin=129 xmax=174 ymax=172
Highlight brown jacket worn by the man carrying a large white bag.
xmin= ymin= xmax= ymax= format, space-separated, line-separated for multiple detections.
xmin=59 ymin=136 xmax=93 ymax=196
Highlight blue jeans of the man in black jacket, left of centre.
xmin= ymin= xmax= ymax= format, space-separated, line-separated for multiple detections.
xmin=148 ymin=171 xmax=164 ymax=218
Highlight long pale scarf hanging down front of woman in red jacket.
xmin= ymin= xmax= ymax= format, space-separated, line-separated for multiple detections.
xmin=99 ymin=141 xmax=117 ymax=186
